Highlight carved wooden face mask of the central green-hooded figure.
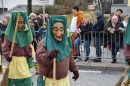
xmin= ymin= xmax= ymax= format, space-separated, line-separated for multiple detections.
xmin=52 ymin=22 xmax=64 ymax=41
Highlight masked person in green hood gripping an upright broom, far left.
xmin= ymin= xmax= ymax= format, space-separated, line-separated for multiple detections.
xmin=2 ymin=12 xmax=33 ymax=86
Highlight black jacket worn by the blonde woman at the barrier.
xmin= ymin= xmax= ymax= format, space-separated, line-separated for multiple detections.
xmin=79 ymin=23 xmax=93 ymax=41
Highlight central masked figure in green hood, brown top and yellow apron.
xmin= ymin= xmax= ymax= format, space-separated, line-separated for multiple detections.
xmin=36 ymin=16 xmax=79 ymax=86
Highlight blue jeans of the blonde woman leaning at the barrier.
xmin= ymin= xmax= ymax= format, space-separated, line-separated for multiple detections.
xmin=74 ymin=37 xmax=90 ymax=57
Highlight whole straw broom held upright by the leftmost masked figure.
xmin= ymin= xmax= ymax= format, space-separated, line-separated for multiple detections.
xmin=0 ymin=11 xmax=20 ymax=86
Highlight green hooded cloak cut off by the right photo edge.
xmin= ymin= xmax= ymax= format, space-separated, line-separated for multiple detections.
xmin=124 ymin=18 xmax=130 ymax=45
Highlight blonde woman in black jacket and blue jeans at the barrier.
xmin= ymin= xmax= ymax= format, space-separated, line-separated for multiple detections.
xmin=74 ymin=13 xmax=93 ymax=61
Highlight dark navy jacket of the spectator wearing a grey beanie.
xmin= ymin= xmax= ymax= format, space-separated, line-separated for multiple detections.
xmin=92 ymin=16 xmax=104 ymax=38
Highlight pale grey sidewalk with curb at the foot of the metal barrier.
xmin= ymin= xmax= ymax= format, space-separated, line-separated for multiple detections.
xmin=76 ymin=59 xmax=126 ymax=70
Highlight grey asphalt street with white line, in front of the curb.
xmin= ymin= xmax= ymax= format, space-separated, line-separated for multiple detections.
xmin=0 ymin=68 xmax=127 ymax=86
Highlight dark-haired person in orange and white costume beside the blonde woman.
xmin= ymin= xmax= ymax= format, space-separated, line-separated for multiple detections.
xmin=70 ymin=6 xmax=83 ymax=56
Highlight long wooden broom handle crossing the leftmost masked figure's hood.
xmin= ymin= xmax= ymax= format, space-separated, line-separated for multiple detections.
xmin=7 ymin=11 xmax=20 ymax=68
